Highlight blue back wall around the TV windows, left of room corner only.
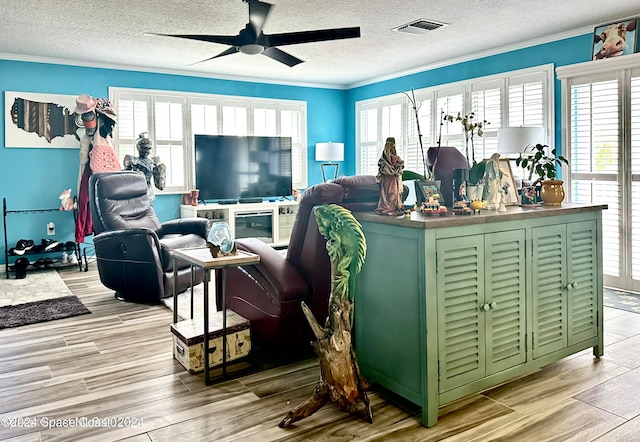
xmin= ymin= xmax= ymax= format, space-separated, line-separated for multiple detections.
xmin=0 ymin=60 xmax=347 ymax=263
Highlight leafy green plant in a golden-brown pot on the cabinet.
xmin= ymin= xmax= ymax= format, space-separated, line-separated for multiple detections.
xmin=516 ymin=144 xmax=569 ymax=205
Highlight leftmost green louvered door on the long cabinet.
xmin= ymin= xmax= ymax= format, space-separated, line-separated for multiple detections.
xmin=436 ymin=235 xmax=485 ymax=392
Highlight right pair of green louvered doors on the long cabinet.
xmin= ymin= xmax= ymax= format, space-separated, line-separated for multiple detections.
xmin=531 ymin=221 xmax=599 ymax=358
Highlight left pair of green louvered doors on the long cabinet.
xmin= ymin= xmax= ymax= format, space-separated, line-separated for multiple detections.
xmin=436 ymin=230 xmax=526 ymax=393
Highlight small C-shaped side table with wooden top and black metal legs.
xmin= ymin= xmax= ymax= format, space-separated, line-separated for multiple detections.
xmin=173 ymin=247 xmax=260 ymax=385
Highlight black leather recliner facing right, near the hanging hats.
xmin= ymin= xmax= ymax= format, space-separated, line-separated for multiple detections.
xmin=89 ymin=171 xmax=207 ymax=304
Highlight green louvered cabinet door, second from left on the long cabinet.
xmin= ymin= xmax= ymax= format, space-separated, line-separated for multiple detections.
xmin=481 ymin=230 xmax=527 ymax=374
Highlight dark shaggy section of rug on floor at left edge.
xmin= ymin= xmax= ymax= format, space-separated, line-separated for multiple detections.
xmin=0 ymin=295 xmax=91 ymax=329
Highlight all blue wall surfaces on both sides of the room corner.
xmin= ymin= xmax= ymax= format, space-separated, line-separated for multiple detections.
xmin=0 ymin=34 xmax=592 ymax=266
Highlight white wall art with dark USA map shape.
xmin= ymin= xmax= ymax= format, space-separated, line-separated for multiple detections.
xmin=4 ymin=91 xmax=80 ymax=149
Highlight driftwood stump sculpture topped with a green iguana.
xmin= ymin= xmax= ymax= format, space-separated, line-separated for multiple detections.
xmin=279 ymin=204 xmax=373 ymax=428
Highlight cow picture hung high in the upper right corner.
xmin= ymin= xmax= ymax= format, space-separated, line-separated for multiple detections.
xmin=591 ymin=17 xmax=639 ymax=60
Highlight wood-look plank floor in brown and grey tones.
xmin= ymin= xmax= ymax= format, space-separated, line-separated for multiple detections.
xmin=0 ymin=265 xmax=640 ymax=442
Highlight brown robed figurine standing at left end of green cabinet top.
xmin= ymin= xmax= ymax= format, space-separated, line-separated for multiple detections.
xmin=376 ymin=137 xmax=404 ymax=216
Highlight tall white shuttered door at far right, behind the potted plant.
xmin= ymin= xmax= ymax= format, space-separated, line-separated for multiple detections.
xmin=557 ymin=59 xmax=640 ymax=291
